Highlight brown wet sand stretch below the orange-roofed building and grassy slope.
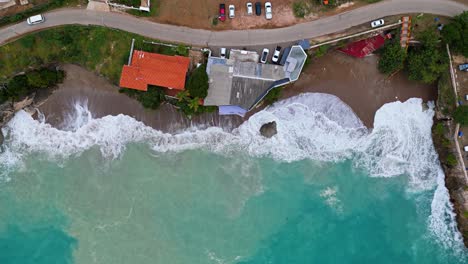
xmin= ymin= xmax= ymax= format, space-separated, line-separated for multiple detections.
xmin=39 ymin=65 xmax=243 ymax=133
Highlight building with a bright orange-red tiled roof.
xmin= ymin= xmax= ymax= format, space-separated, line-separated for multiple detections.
xmin=120 ymin=50 xmax=190 ymax=96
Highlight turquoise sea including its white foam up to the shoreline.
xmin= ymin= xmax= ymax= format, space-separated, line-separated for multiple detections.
xmin=0 ymin=94 xmax=468 ymax=264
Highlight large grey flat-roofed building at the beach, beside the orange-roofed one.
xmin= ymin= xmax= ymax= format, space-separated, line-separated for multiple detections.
xmin=204 ymin=45 xmax=307 ymax=116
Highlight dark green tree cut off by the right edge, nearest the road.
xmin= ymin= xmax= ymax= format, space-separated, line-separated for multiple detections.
xmin=442 ymin=11 xmax=468 ymax=57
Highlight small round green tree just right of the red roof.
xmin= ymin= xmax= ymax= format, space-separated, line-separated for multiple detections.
xmin=378 ymin=41 xmax=406 ymax=74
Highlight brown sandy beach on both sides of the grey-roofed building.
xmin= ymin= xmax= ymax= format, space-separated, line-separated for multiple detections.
xmin=39 ymin=52 xmax=437 ymax=133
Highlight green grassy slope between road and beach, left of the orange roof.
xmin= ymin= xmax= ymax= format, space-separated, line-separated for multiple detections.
xmin=0 ymin=25 xmax=186 ymax=84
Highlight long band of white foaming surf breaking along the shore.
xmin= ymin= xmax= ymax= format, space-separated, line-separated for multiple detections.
xmin=0 ymin=93 xmax=460 ymax=250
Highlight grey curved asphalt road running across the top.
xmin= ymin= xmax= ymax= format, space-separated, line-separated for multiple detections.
xmin=0 ymin=0 xmax=468 ymax=47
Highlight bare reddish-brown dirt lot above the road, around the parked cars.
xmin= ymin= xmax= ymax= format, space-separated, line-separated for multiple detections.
xmin=150 ymin=0 xmax=363 ymax=30
